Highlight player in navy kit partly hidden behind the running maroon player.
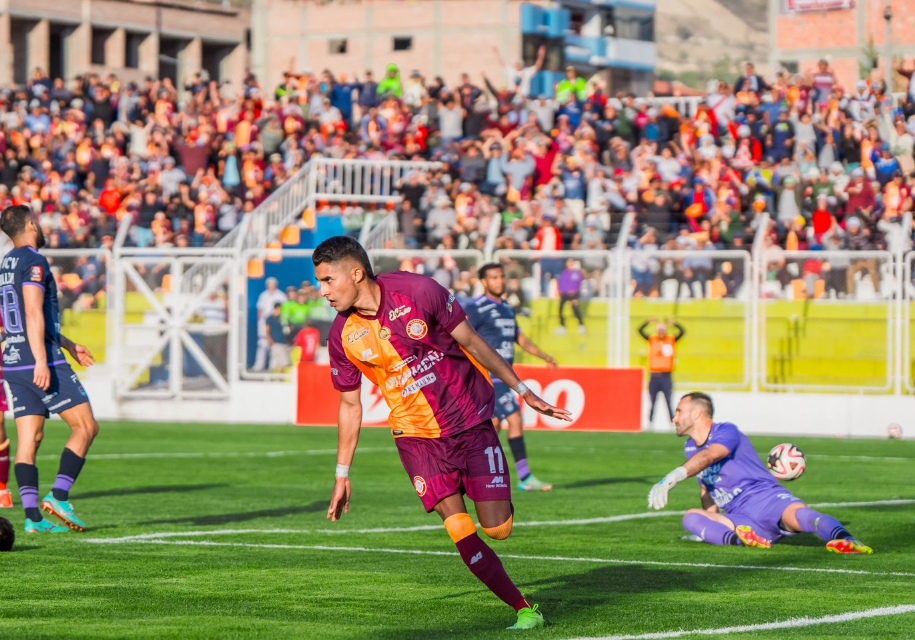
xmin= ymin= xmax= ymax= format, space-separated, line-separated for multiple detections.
xmin=467 ymin=263 xmax=556 ymax=491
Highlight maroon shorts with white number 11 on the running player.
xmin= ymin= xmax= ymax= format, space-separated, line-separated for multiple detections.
xmin=394 ymin=420 xmax=511 ymax=511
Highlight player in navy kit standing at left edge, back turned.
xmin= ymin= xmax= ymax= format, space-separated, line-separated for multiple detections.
xmin=0 ymin=205 xmax=98 ymax=533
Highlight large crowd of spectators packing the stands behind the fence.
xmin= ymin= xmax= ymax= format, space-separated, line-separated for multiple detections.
xmin=0 ymin=51 xmax=915 ymax=306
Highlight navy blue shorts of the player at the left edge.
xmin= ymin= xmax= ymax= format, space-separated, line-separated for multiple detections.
xmin=3 ymin=362 xmax=89 ymax=418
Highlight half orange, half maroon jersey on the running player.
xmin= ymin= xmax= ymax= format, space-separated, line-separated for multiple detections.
xmin=327 ymin=271 xmax=494 ymax=438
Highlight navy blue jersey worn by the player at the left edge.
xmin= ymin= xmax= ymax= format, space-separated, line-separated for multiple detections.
xmin=0 ymin=247 xmax=66 ymax=371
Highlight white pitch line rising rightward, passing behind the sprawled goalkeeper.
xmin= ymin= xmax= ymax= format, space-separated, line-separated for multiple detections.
xmin=85 ymin=499 xmax=915 ymax=543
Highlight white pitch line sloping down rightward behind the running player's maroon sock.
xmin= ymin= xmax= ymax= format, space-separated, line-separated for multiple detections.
xmin=85 ymin=536 xmax=915 ymax=578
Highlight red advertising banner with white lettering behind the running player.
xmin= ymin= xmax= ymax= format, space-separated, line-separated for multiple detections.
xmin=296 ymin=362 xmax=644 ymax=431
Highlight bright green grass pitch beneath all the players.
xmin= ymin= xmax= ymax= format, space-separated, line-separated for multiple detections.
xmin=0 ymin=422 xmax=915 ymax=640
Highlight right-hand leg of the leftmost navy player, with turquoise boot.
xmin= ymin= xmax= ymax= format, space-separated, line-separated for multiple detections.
xmin=41 ymin=402 xmax=98 ymax=531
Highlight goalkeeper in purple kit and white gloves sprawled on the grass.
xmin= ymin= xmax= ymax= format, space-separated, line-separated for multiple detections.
xmin=648 ymin=392 xmax=872 ymax=554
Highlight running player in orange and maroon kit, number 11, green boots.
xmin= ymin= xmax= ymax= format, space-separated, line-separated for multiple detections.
xmin=312 ymin=236 xmax=570 ymax=629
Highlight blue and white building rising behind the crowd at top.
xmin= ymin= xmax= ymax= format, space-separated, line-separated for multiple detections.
xmin=521 ymin=0 xmax=657 ymax=96
